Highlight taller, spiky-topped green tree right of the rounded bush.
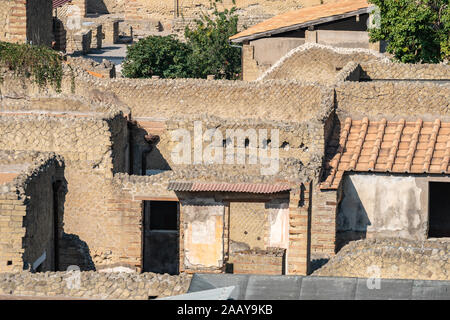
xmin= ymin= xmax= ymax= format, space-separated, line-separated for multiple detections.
xmin=185 ymin=0 xmax=241 ymax=79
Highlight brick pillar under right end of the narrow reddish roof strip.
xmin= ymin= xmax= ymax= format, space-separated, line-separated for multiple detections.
xmin=287 ymin=184 xmax=311 ymax=275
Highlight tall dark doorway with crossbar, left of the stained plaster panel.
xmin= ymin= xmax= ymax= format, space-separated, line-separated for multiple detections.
xmin=143 ymin=201 xmax=179 ymax=274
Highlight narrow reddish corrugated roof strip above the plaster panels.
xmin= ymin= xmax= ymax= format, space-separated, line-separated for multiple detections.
xmin=168 ymin=182 xmax=291 ymax=193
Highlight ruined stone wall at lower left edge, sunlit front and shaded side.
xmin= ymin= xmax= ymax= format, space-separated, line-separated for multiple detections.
xmin=0 ymin=152 xmax=65 ymax=272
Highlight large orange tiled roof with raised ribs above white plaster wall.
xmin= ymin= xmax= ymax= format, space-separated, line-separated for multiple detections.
xmin=321 ymin=118 xmax=450 ymax=189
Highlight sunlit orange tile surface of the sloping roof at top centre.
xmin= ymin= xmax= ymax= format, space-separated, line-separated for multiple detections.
xmin=230 ymin=0 xmax=371 ymax=40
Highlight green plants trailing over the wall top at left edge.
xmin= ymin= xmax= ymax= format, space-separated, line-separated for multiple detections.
xmin=0 ymin=42 xmax=63 ymax=91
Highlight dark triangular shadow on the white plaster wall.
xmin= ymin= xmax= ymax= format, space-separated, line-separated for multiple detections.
xmin=336 ymin=176 xmax=372 ymax=252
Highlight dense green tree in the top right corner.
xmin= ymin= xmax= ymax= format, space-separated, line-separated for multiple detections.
xmin=369 ymin=0 xmax=450 ymax=63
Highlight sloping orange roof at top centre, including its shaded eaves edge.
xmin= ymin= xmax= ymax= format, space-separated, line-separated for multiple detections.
xmin=230 ymin=0 xmax=372 ymax=42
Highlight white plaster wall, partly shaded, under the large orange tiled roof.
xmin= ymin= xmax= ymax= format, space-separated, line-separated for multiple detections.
xmin=337 ymin=174 xmax=427 ymax=239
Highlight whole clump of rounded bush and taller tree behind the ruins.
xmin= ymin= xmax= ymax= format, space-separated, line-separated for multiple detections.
xmin=122 ymin=0 xmax=241 ymax=79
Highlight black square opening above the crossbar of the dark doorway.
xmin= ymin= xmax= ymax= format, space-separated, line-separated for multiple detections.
xmin=149 ymin=201 xmax=178 ymax=230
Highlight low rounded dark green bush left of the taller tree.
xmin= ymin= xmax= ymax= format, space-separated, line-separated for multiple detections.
xmin=122 ymin=35 xmax=190 ymax=78
